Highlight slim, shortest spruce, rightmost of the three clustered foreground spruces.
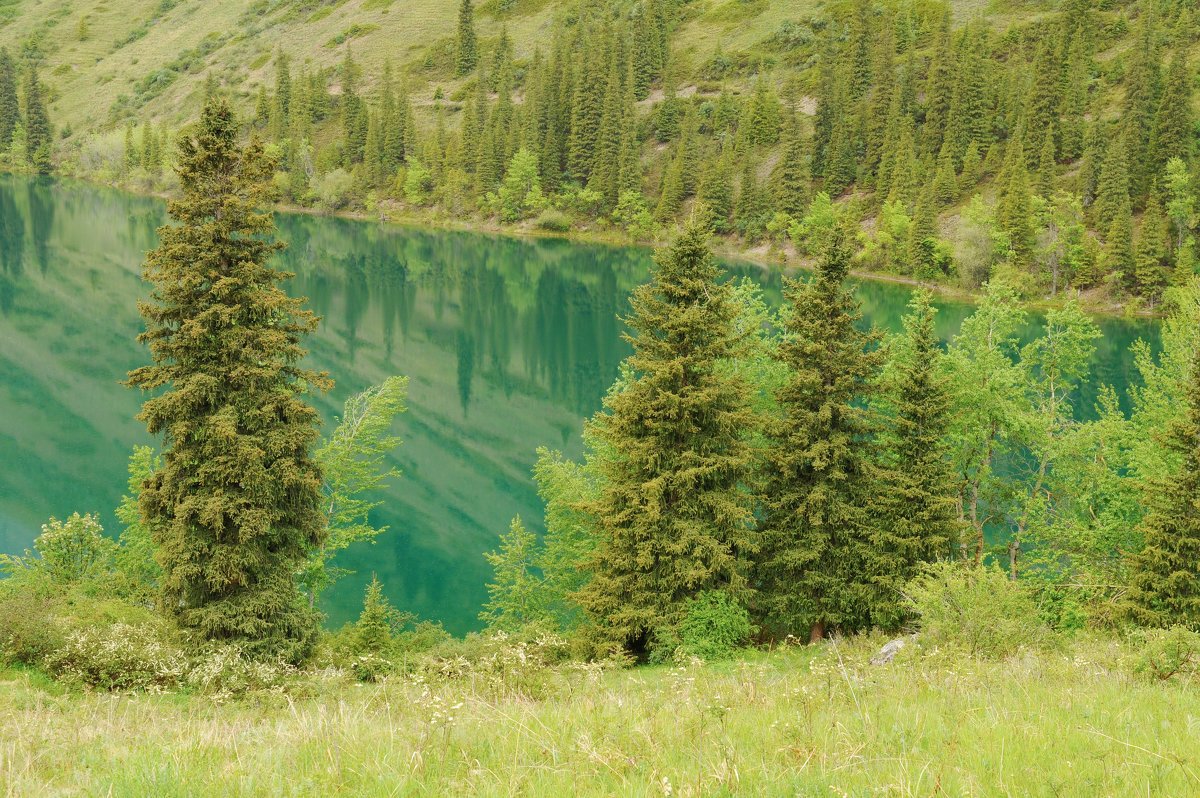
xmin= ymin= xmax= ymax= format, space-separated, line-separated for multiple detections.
xmin=872 ymin=288 xmax=960 ymax=628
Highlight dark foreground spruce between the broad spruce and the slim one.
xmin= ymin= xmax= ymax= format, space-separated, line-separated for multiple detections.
xmin=758 ymin=227 xmax=883 ymax=641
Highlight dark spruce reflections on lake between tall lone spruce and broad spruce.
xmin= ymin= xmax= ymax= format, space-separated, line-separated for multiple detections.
xmin=280 ymin=217 xmax=647 ymax=415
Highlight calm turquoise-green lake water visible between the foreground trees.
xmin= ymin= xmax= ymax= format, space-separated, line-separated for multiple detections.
xmin=0 ymin=174 xmax=1158 ymax=632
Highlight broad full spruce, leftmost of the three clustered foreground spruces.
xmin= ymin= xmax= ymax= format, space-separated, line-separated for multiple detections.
xmin=577 ymin=226 xmax=755 ymax=653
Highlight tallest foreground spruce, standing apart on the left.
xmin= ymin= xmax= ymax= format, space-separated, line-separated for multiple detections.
xmin=128 ymin=97 xmax=330 ymax=662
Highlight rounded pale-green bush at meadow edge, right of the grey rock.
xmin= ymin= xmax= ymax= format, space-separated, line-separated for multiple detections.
xmin=906 ymin=563 xmax=1050 ymax=659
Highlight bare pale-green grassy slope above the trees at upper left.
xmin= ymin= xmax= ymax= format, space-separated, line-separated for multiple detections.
xmin=0 ymin=0 xmax=556 ymax=131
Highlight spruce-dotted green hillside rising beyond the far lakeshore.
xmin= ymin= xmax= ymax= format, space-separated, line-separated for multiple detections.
xmin=0 ymin=0 xmax=1198 ymax=304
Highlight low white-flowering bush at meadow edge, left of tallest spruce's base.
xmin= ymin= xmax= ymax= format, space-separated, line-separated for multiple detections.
xmin=44 ymin=623 xmax=187 ymax=691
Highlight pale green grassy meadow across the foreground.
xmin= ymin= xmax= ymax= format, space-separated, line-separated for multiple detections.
xmin=0 ymin=637 xmax=1200 ymax=797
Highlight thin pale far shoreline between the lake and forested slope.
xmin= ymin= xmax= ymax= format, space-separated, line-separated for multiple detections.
xmin=0 ymin=169 xmax=1164 ymax=319
